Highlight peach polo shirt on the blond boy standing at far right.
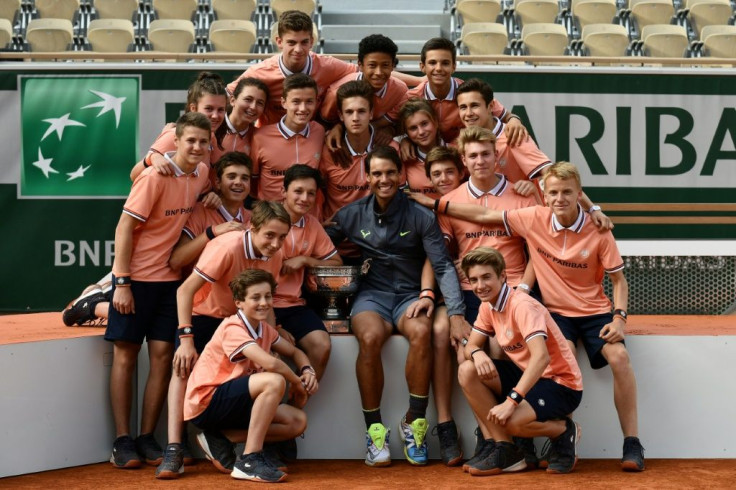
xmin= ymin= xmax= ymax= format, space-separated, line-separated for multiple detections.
xmin=503 ymin=205 xmax=624 ymax=317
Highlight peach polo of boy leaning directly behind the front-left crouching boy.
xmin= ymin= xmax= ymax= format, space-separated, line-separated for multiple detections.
xmin=192 ymin=230 xmax=282 ymax=318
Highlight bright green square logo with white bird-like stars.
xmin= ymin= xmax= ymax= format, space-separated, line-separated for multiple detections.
xmin=19 ymin=76 xmax=139 ymax=198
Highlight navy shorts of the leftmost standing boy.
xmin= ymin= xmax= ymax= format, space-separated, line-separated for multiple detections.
xmin=105 ymin=276 xmax=181 ymax=345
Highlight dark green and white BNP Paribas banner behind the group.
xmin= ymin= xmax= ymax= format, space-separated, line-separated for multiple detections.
xmin=0 ymin=63 xmax=736 ymax=312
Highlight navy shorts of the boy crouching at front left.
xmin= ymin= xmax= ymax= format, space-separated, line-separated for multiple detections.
xmin=191 ymin=376 xmax=254 ymax=431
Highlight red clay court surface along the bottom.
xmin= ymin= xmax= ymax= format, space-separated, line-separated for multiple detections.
xmin=0 ymin=460 xmax=736 ymax=490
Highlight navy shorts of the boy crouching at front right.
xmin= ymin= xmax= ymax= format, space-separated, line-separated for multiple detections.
xmin=493 ymin=359 xmax=583 ymax=422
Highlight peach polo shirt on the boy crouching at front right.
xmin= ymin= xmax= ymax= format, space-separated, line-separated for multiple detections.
xmin=473 ymin=284 xmax=583 ymax=391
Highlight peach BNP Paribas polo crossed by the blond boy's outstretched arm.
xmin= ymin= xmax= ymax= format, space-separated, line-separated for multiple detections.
xmin=438 ymin=174 xmax=536 ymax=291
